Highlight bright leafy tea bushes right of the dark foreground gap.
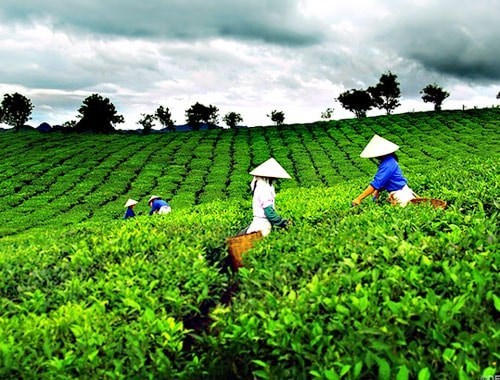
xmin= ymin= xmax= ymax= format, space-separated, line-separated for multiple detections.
xmin=211 ymin=177 xmax=500 ymax=378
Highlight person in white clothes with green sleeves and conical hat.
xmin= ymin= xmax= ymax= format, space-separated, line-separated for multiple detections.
xmin=242 ymin=158 xmax=291 ymax=236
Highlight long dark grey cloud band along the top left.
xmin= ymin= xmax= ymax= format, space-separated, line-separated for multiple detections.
xmin=0 ymin=0 xmax=324 ymax=46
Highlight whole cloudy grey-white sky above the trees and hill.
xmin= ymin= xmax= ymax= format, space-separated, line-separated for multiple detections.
xmin=0 ymin=0 xmax=500 ymax=129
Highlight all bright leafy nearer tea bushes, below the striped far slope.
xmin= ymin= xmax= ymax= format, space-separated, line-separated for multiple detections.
xmin=0 ymin=156 xmax=500 ymax=379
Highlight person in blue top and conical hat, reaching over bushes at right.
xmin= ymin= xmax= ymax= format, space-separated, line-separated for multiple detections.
xmin=352 ymin=135 xmax=416 ymax=206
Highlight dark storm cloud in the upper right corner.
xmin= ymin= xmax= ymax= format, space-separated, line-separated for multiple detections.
xmin=377 ymin=0 xmax=500 ymax=82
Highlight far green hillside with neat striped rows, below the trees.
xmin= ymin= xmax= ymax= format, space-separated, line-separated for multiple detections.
xmin=0 ymin=109 xmax=500 ymax=236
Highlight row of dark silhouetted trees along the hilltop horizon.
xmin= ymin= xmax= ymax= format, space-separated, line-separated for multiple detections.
xmin=0 ymin=82 xmax=500 ymax=134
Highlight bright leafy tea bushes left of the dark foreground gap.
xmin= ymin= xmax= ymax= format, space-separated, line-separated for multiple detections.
xmin=0 ymin=209 xmax=240 ymax=378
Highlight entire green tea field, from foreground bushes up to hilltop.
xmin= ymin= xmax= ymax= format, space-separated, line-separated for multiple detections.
xmin=0 ymin=109 xmax=500 ymax=380
